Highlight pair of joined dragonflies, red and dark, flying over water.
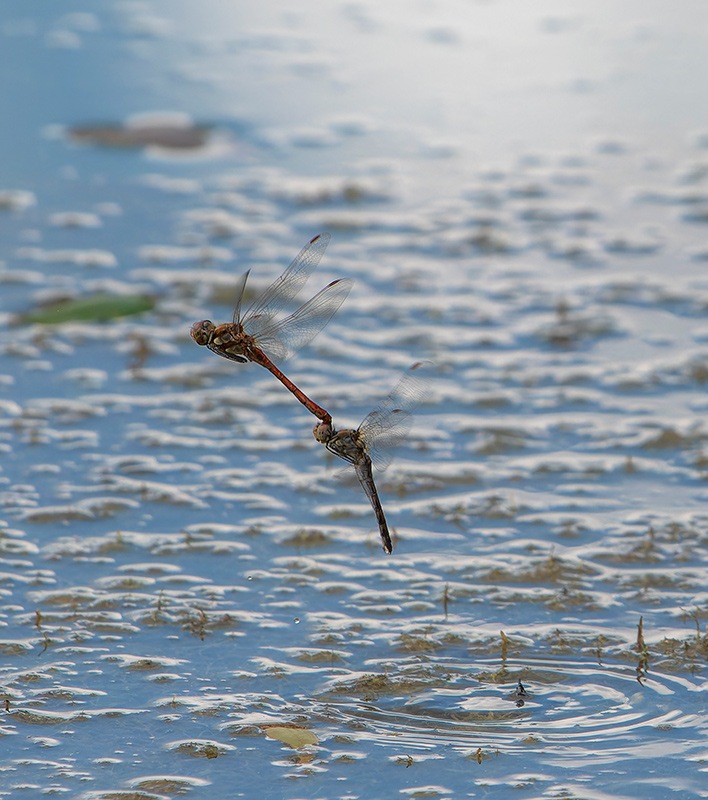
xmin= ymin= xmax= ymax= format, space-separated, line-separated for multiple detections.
xmin=190 ymin=233 xmax=424 ymax=553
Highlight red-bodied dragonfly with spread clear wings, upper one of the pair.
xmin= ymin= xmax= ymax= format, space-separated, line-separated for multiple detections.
xmin=190 ymin=233 xmax=352 ymax=424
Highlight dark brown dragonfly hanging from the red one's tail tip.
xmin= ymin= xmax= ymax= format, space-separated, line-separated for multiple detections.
xmin=312 ymin=361 xmax=430 ymax=555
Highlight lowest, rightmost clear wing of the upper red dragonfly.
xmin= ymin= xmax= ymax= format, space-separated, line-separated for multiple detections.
xmin=254 ymin=278 xmax=352 ymax=362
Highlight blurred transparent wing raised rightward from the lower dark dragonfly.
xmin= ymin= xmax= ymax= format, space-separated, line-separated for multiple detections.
xmin=358 ymin=361 xmax=430 ymax=469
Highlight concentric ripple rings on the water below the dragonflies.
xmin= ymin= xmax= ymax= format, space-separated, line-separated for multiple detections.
xmin=316 ymin=659 xmax=708 ymax=764
